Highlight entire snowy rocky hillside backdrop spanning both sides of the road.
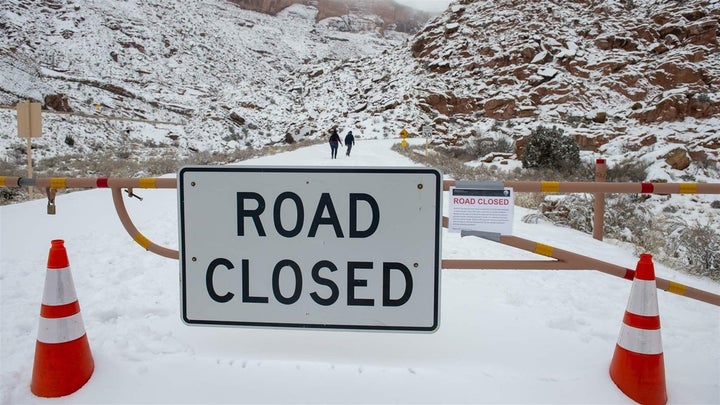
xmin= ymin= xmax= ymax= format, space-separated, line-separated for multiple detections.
xmin=0 ymin=0 xmax=720 ymax=173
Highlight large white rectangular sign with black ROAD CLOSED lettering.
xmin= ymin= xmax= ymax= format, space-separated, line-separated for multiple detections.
xmin=178 ymin=166 xmax=442 ymax=332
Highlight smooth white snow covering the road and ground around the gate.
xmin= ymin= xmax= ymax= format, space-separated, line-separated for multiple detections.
xmin=0 ymin=140 xmax=720 ymax=404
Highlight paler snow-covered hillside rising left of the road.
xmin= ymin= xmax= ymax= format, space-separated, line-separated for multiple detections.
xmin=0 ymin=0 xmax=406 ymax=160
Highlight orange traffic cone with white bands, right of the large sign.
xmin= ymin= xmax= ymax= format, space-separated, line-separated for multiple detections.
xmin=610 ymin=254 xmax=667 ymax=404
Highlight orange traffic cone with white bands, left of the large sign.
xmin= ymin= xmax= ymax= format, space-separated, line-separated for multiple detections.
xmin=30 ymin=240 xmax=95 ymax=397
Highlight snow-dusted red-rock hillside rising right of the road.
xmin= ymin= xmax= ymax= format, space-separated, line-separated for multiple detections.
xmin=309 ymin=0 xmax=720 ymax=165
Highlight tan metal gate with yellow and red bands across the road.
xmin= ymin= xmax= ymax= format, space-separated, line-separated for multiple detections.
xmin=0 ymin=176 xmax=720 ymax=306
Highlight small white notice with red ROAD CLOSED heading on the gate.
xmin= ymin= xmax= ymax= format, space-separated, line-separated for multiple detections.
xmin=448 ymin=187 xmax=515 ymax=235
